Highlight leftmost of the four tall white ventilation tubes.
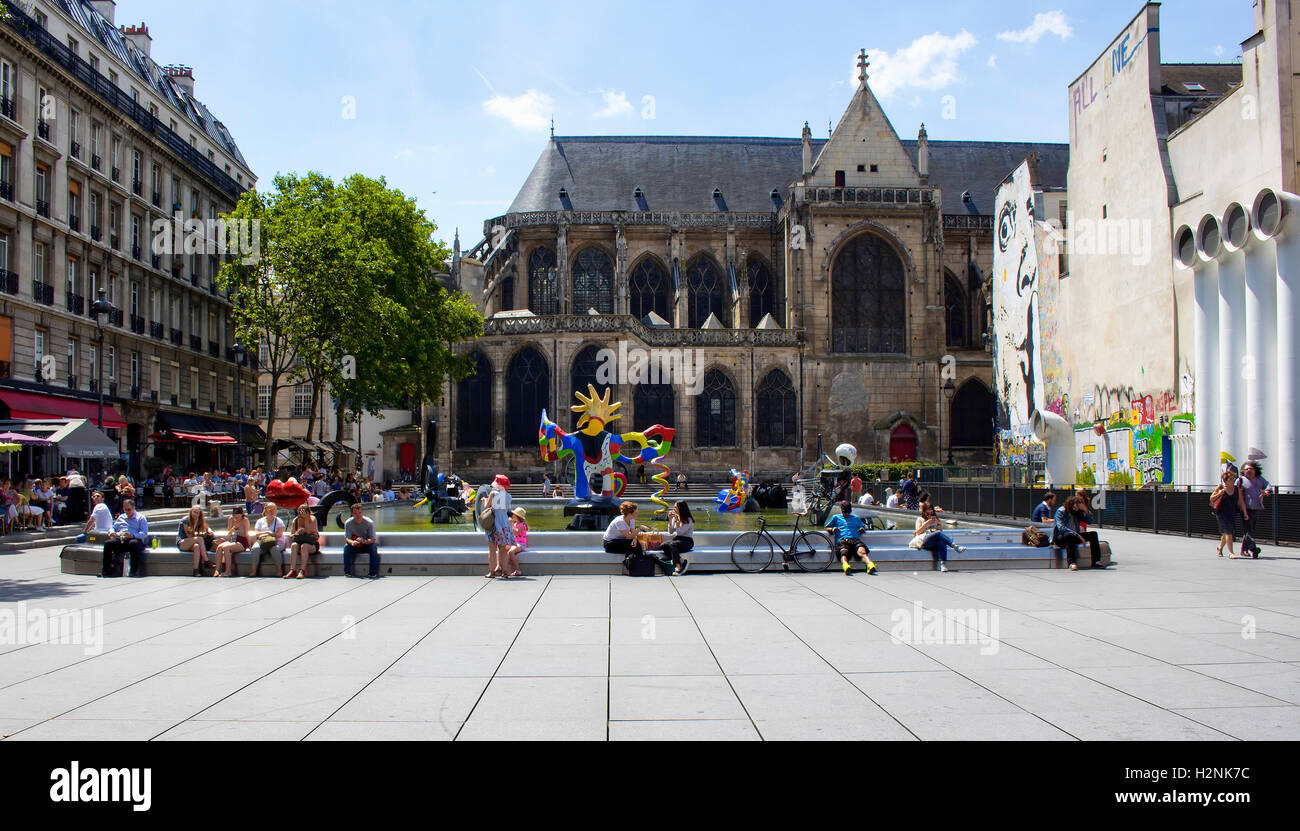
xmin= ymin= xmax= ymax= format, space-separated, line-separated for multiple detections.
xmin=1174 ymin=225 xmax=1218 ymax=488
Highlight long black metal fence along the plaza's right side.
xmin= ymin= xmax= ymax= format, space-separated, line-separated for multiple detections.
xmin=923 ymin=482 xmax=1300 ymax=545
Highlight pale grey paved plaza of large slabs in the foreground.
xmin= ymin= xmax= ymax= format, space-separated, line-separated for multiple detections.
xmin=0 ymin=531 xmax=1300 ymax=741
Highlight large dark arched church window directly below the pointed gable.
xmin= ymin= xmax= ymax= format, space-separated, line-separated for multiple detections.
xmin=831 ymin=234 xmax=907 ymax=354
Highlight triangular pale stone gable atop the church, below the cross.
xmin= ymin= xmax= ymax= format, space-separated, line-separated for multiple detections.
xmin=807 ymin=82 xmax=920 ymax=187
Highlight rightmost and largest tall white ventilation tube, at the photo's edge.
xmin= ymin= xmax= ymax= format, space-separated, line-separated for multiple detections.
xmin=1251 ymin=189 xmax=1300 ymax=488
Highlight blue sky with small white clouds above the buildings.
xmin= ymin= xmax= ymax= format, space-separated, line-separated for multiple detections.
xmin=117 ymin=0 xmax=1237 ymax=248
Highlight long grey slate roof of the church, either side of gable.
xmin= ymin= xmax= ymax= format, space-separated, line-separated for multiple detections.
xmin=510 ymin=135 xmax=1070 ymax=213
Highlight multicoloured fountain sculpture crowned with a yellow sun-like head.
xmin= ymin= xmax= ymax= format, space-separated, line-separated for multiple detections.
xmin=537 ymin=384 xmax=676 ymax=515
